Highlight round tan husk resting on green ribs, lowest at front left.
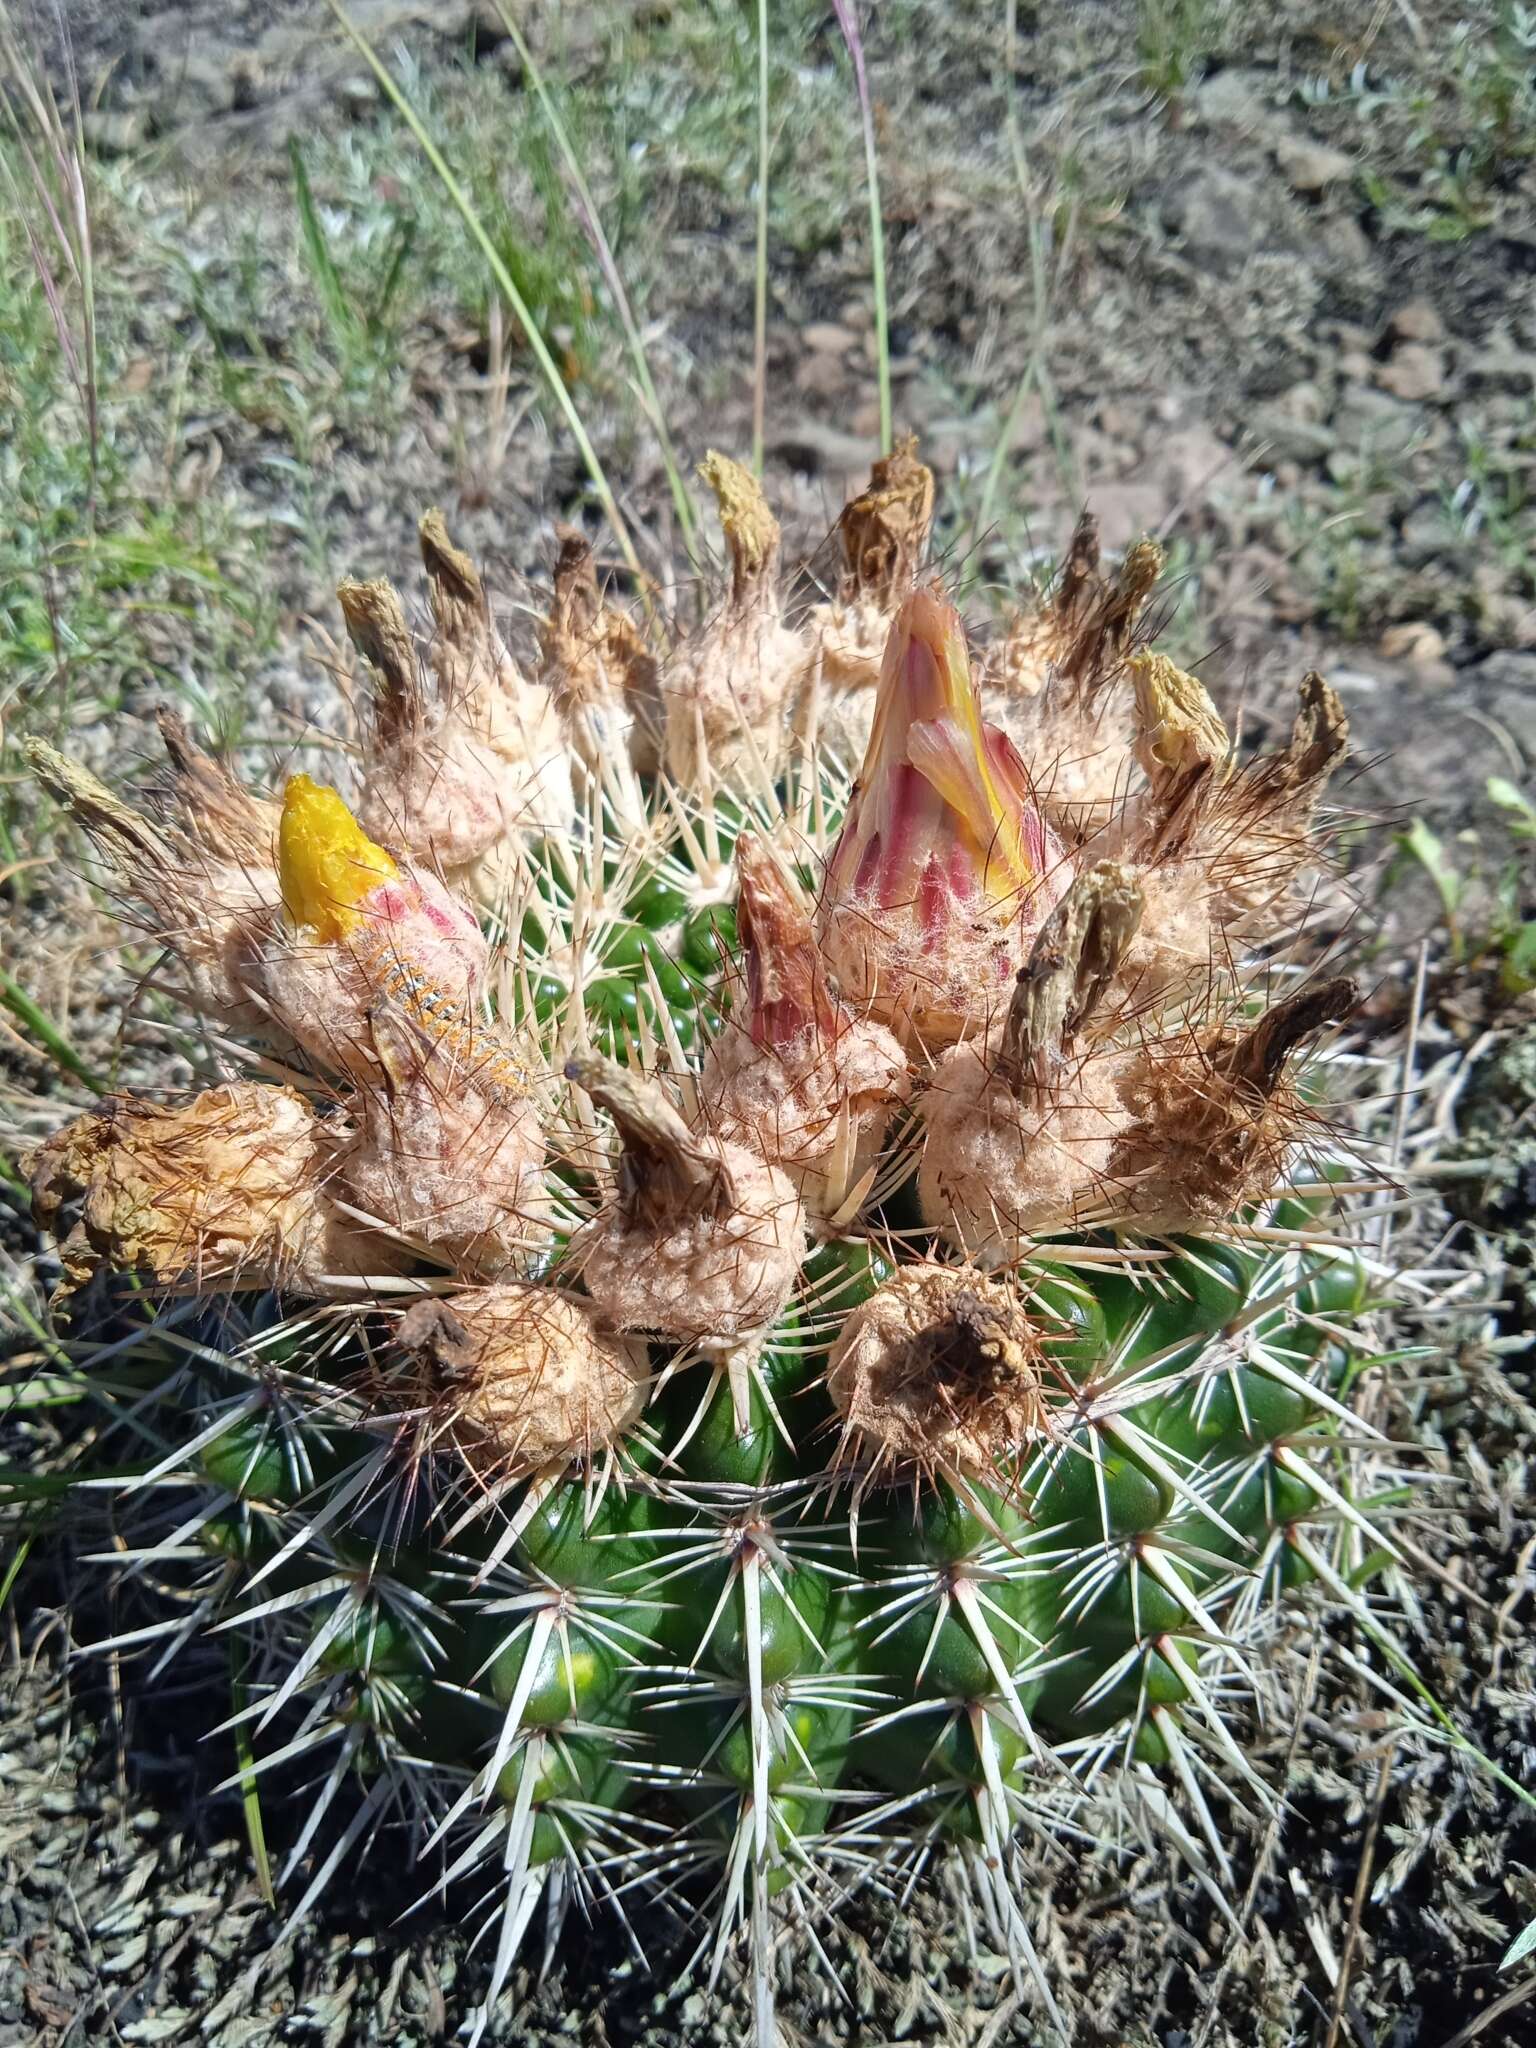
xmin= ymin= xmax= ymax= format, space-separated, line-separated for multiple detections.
xmin=387 ymin=1284 xmax=645 ymax=1481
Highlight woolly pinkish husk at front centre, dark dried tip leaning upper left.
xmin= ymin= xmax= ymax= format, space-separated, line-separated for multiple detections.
xmin=565 ymin=1059 xmax=805 ymax=1343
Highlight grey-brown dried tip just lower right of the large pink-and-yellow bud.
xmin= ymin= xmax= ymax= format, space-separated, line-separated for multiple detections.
xmin=997 ymin=860 xmax=1145 ymax=1092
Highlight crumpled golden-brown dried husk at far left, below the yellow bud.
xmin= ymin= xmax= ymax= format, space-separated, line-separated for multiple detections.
xmin=29 ymin=1083 xmax=391 ymax=1294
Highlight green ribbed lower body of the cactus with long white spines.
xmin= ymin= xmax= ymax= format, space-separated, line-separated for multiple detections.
xmin=90 ymin=1212 xmax=1368 ymax=2031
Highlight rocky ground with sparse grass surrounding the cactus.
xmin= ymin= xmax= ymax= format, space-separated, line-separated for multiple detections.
xmin=0 ymin=0 xmax=1536 ymax=2048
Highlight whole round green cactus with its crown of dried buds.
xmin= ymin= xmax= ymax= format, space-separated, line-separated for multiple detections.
xmin=31 ymin=456 xmax=1384 ymax=2044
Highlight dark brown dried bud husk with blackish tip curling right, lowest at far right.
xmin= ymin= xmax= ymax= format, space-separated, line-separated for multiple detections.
xmin=1106 ymin=979 xmax=1360 ymax=1235
